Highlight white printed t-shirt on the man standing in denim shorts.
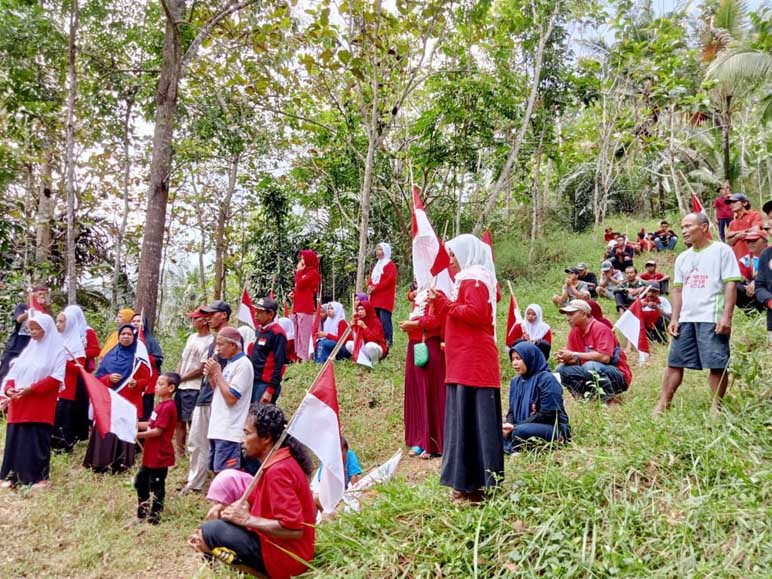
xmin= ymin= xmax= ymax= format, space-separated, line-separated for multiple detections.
xmin=673 ymin=241 xmax=742 ymax=324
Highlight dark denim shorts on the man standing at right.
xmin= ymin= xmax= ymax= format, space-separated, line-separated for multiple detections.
xmin=667 ymin=322 xmax=729 ymax=370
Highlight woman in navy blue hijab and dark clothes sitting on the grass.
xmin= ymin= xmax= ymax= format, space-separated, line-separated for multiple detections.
xmin=502 ymin=341 xmax=571 ymax=453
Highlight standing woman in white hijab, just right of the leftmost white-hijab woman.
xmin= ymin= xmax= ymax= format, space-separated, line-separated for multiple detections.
xmin=51 ymin=305 xmax=89 ymax=452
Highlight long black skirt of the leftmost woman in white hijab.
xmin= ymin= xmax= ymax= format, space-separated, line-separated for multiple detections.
xmin=0 ymin=422 xmax=53 ymax=485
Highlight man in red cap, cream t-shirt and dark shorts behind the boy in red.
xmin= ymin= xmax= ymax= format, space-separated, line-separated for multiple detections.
xmin=174 ymin=307 xmax=214 ymax=456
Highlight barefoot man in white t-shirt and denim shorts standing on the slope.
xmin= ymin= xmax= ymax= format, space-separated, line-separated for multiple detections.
xmin=654 ymin=213 xmax=742 ymax=416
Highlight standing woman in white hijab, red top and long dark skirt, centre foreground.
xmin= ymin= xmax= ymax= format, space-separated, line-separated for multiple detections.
xmin=429 ymin=234 xmax=504 ymax=502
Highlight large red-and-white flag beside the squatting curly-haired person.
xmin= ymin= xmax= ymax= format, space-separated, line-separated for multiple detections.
xmin=287 ymin=364 xmax=346 ymax=513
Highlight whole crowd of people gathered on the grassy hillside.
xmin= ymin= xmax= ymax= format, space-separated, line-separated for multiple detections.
xmin=0 ymin=194 xmax=772 ymax=577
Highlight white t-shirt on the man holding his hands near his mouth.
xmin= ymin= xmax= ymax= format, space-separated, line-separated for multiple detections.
xmin=207 ymin=352 xmax=255 ymax=442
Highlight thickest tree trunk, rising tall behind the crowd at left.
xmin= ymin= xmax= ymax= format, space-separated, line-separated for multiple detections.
xmin=136 ymin=0 xmax=185 ymax=328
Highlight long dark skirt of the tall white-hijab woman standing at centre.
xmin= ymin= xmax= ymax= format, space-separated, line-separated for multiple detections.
xmin=440 ymin=384 xmax=504 ymax=492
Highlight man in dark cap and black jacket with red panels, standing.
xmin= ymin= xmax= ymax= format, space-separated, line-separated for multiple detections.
xmin=249 ymin=298 xmax=286 ymax=404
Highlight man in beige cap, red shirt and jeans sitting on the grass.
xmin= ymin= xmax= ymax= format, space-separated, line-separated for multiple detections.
xmin=555 ymin=300 xmax=633 ymax=403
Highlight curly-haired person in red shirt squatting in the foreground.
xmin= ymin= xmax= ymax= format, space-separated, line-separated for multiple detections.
xmin=189 ymin=404 xmax=316 ymax=579
